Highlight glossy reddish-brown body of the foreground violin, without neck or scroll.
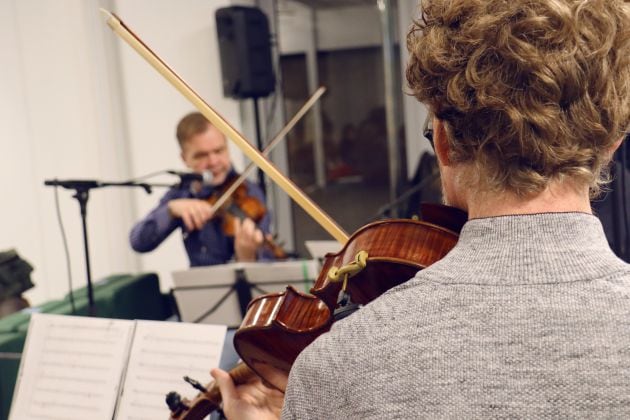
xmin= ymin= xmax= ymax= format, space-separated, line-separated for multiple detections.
xmin=234 ymin=215 xmax=457 ymax=391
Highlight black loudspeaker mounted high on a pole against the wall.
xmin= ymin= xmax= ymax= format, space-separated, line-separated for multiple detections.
xmin=215 ymin=6 xmax=276 ymax=99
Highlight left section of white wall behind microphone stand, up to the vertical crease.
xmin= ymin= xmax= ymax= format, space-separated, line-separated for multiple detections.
xmin=0 ymin=0 xmax=138 ymax=303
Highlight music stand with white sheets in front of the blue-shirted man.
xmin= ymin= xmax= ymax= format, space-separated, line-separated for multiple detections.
xmin=171 ymin=260 xmax=319 ymax=327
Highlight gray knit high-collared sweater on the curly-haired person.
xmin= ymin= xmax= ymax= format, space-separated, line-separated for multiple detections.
xmin=283 ymin=213 xmax=630 ymax=419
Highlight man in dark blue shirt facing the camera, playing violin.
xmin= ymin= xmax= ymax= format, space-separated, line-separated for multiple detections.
xmin=130 ymin=112 xmax=271 ymax=266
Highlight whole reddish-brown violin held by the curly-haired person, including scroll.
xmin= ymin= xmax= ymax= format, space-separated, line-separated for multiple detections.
xmin=167 ymin=204 xmax=467 ymax=420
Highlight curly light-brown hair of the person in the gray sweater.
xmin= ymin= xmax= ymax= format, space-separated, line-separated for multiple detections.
xmin=406 ymin=0 xmax=630 ymax=196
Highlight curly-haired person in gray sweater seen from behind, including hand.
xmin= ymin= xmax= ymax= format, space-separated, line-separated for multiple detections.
xmin=213 ymin=0 xmax=630 ymax=419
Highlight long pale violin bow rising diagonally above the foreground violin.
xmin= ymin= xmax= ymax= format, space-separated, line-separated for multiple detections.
xmin=101 ymin=9 xmax=349 ymax=245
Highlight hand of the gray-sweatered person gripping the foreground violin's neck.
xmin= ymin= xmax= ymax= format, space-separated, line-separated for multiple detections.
xmin=210 ymin=369 xmax=284 ymax=420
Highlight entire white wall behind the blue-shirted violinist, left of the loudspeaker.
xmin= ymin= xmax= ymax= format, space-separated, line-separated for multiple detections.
xmin=0 ymin=0 xmax=252 ymax=304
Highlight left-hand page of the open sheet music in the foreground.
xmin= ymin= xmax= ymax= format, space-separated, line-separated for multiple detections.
xmin=9 ymin=313 xmax=134 ymax=420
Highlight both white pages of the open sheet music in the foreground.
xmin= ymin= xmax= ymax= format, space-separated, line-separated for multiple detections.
xmin=9 ymin=314 xmax=226 ymax=420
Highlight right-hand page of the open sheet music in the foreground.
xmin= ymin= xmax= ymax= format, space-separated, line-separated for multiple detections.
xmin=116 ymin=321 xmax=227 ymax=420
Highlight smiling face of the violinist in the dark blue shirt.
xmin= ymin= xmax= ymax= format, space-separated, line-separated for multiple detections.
xmin=181 ymin=124 xmax=231 ymax=185
